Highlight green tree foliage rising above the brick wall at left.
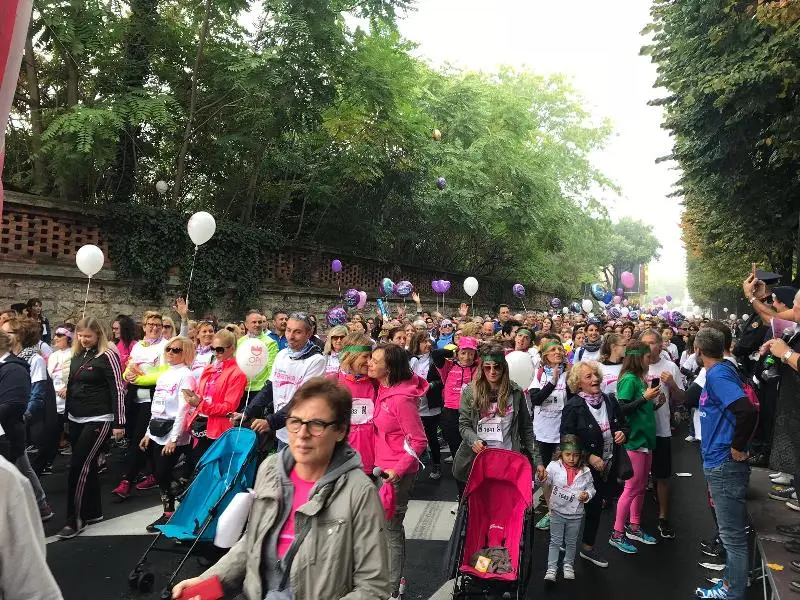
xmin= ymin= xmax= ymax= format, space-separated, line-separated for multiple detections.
xmin=4 ymin=0 xmax=656 ymax=294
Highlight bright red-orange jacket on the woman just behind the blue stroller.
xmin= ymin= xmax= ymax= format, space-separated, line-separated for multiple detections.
xmin=187 ymin=358 xmax=247 ymax=440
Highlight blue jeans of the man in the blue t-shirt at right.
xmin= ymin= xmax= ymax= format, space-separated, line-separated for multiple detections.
xmin=703 ymin=459 xmax=750 ymax=600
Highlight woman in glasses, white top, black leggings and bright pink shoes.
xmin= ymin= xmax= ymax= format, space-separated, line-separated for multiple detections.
xmin=111 ymin=311 xmax=167 ymax=500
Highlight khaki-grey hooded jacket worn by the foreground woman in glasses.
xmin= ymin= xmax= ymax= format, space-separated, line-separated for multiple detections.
xmin=201 ymin=443 xmax=391 ymax=600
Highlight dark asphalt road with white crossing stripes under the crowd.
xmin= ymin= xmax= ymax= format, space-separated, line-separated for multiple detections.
xmin=42 ymin=432 xmax=760 ymax=600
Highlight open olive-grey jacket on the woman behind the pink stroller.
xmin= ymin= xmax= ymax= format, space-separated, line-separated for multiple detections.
xmin=453 ymin=381 xmax=539 ymax=481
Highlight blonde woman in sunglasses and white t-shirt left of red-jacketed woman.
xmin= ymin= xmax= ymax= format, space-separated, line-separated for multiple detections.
xmin=139 ymin=337 xmax=197 ymax=533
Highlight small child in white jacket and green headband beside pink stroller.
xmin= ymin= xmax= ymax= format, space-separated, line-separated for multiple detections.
xmin=536 ymin=435 xmax=595 ymax=583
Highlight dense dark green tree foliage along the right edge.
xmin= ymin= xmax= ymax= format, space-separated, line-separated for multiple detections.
xmin=643 ymin=0 xmax=800 ymax=304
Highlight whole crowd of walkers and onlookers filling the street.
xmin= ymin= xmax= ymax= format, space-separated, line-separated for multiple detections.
xmin=0 ymin=277 xmax=800 ymax=600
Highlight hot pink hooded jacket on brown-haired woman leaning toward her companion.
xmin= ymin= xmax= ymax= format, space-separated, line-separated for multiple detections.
xmin=374 ymin=375 xmax=429 ymax=476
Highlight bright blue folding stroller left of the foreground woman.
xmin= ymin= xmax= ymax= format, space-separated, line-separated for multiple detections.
xmin=128 ymin=427 xmax=258 ymax=600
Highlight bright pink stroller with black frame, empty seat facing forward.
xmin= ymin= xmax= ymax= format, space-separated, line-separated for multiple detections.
xmin=447 ymin=449 xmax=533 ymax=599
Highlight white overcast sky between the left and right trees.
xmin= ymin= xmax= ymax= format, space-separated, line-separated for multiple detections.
xmin=400 ymin=0 xmax=685 ymax=278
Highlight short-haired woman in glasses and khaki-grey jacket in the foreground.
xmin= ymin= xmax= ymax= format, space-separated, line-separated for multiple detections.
xmin=172 ymin=377 xmax=390 ymax=600
